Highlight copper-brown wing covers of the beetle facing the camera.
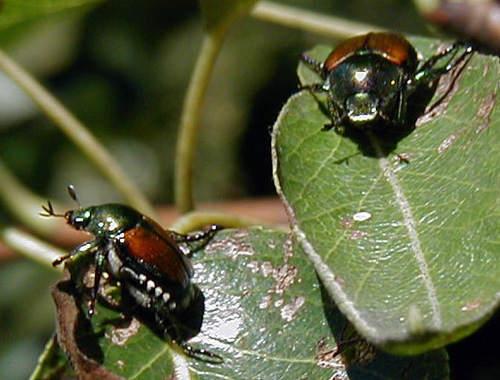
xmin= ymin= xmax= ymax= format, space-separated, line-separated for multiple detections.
xmin=324 ymin=32 xmax=416 ymax=71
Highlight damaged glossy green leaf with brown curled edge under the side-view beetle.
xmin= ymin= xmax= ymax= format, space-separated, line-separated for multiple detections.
xmin=44 ymin=228 xmax=448 ymax=380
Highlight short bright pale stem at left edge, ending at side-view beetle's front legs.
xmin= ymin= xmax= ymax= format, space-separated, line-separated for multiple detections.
xmin=0 ymin=227 xmax=67 ymax=270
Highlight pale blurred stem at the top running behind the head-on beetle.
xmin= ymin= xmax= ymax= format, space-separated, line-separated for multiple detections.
xmin=251 ymin=1 xmax=381 ymax=38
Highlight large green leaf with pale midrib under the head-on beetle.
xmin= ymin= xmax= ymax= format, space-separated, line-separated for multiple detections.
xmin=273 ymin=39 xmax=500 ymax=353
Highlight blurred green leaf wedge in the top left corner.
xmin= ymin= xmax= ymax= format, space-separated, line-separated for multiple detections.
xmin=0 ymin=0 xmax=103 ymax=29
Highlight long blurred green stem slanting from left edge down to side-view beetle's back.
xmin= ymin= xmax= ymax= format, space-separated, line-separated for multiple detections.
xmin=0 ymin=49 xmax=156 ymax=217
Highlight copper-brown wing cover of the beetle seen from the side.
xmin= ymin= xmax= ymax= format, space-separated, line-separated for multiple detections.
xmin=124 ymin=227 xmax=193 ymax=285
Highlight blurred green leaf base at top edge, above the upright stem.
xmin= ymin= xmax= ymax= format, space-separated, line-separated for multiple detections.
xmin=199 ymin=0 xmax=257 ymax=31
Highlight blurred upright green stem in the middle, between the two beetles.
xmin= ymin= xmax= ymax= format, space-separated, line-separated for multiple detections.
xmin=175 ymin=32 xmax=226 ymax=213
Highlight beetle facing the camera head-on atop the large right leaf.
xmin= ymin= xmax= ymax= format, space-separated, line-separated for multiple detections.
xmin=301 ymin=32 xmax=472 ymax=130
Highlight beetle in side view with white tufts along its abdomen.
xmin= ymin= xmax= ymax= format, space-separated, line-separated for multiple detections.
xmin=42 ymin=186 xmax=222 ymax=362
